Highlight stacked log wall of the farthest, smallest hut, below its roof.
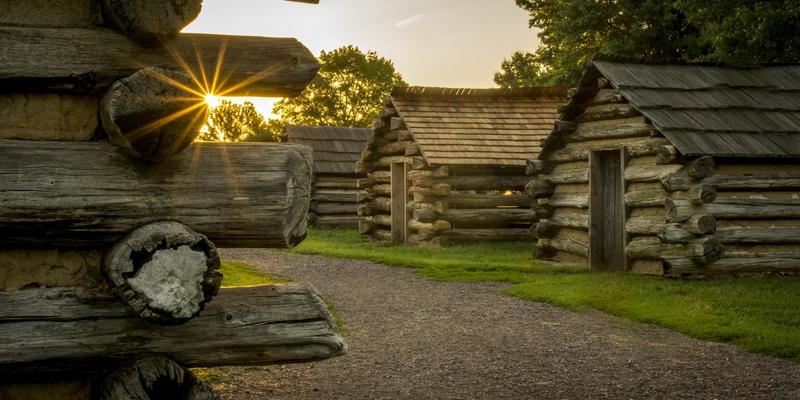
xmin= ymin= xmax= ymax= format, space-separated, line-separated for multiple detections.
xmin=309 ymin=174 xmax=365 ymax=228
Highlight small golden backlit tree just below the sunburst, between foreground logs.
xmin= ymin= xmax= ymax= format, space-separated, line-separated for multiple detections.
xmin=199 ymin=100 xmax=279 ymax=142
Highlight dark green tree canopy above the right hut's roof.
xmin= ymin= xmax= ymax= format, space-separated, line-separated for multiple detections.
xmin=495 ymin=0 xmax=800 ymax=87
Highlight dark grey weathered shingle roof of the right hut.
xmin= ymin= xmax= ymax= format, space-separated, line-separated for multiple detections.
xmin=593 ymin=61 xmax=800 ymax=157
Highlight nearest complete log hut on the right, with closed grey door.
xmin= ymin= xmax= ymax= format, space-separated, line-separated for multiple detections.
xmin=528 ymin=60 xmax=800 ymax=276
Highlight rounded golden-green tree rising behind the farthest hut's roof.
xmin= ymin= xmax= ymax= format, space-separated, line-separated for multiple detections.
xmin=273 ymin=46 xmax=405 ymax=127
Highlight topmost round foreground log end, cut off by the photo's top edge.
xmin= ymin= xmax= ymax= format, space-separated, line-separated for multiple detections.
xmin=100 ymin=0 xmax=203 ymax=45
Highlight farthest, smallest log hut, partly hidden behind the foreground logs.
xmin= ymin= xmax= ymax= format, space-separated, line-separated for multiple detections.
xmin=286 ymin=125 xmax=370 ymax=228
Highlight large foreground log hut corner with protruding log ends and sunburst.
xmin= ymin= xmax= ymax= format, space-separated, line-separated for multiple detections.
xmin=0 ymin=0 xmax=346 ymax=400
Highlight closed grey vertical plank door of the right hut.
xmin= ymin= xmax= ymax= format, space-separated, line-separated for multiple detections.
xmin=589 ymin=150 xmax=627 ymax=271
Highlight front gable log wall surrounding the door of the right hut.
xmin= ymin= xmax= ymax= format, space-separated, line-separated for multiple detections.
xmin=527 ymin=79 xmax=722 ymax=274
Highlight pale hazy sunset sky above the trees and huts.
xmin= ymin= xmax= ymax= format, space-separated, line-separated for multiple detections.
xmin=184 ymin=0 xmax=538 ymax=115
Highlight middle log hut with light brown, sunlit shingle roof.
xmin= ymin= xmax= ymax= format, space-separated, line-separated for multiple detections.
xmin=358 ymin=87 xmax=566 ymax=245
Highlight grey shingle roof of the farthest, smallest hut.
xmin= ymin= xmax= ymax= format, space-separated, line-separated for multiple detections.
xmin=286 ymin=125 xmax=372 ymax=175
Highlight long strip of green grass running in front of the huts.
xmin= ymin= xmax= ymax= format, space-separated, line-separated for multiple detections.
xmin=290 ymin=229 xmax=800 ymax=362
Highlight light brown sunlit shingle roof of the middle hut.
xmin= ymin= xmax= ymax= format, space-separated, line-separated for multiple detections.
xmin=391 ymin=87 xmax=566 ymax=166
